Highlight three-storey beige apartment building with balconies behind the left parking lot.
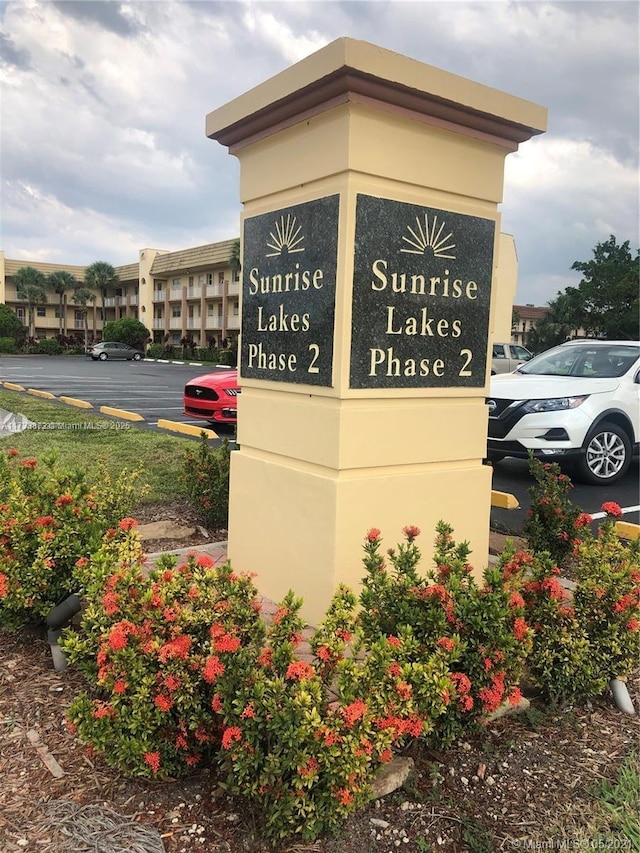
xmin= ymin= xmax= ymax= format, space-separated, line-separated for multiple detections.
xmin=0 ymin=240 xmax=240 ymax=347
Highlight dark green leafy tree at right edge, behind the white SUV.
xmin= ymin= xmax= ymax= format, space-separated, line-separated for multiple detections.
xmin=568 ymin=234 xmax=640 ymax=340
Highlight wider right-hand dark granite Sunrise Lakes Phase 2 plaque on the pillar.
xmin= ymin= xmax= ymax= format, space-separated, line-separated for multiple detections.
xmin=350 ymin=195 xmax=495 ymax=388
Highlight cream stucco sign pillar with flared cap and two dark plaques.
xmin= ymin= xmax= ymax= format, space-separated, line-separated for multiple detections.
xmin=206 ymin=39 xmax=546 ymax=623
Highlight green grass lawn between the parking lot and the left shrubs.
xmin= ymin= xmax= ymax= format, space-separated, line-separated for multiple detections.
xmin=0 ymin=388 xmax=195 ymax=504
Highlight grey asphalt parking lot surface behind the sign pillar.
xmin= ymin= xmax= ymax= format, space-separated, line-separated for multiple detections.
xmin=0 ymin=356 xmax=640 ymax=532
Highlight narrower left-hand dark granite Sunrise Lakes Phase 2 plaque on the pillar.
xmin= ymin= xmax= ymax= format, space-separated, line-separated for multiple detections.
xmin=240 ymin=195 xmax=339 ymax=387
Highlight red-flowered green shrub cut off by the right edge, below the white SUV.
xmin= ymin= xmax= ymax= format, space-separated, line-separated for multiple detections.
xmin=523 ymin=502 xmax=640 ymax=703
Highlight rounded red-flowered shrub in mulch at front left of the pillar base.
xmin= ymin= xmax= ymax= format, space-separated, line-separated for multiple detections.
xmin=61 ymin=519 xmax=264 ymax=778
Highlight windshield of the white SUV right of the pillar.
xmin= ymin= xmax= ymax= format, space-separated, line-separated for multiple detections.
xmin=516 ymin=343 xmax=640 ymax=379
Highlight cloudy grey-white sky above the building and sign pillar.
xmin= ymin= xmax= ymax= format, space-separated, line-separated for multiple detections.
xmin=0 ymin=0 xmax=640 ymax=305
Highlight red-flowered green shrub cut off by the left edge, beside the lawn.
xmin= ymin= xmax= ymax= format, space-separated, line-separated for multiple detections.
xmin=0 ymin=450 xmax=145 ymax=627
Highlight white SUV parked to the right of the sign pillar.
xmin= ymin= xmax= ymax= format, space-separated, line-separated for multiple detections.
xmin=487 ymin=340 xmax=640 ymax=484
